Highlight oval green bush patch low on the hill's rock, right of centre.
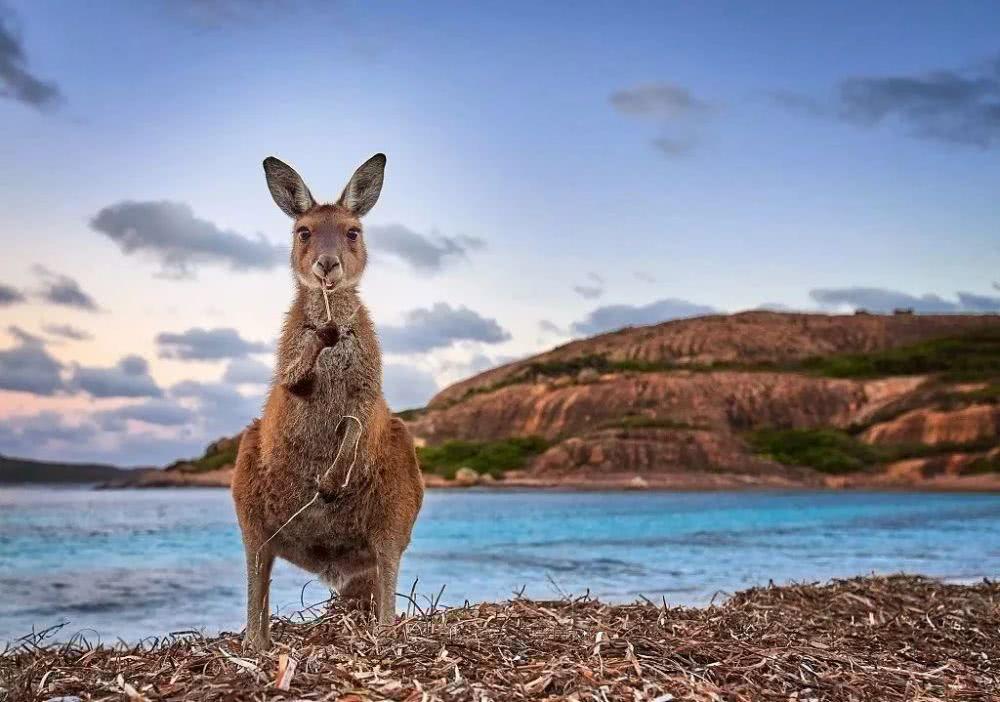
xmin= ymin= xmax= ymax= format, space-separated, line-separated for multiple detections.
xmin=748 ymin=429 xmax=882 ymax=473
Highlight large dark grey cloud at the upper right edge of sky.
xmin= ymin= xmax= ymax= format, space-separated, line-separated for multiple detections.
xmin=772 ymin=56 xmax=1000 ymax=149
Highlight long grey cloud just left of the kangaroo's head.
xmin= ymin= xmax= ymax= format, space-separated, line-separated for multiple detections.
xmin=90 ymin=200 xmax=287 ymax=278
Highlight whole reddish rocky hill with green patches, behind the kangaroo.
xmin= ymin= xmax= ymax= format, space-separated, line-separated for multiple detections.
xmin=111 ymin=312 xmax=1000 ymax=490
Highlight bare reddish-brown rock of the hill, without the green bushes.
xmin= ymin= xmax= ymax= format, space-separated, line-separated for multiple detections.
xmin=410 ymin=312 xmax=1000 ymax=488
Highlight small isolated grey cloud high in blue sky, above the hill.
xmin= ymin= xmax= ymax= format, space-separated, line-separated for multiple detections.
xmin=610 ymin=81 xmax=715 ymax=158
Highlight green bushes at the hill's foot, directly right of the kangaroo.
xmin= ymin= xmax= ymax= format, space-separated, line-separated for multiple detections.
xmin=417 ymin=436 xmax=549 ymax=480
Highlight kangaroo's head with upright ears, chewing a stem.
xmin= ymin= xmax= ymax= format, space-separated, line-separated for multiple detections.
xmin=264 ymin=154 xmax=385 ymax=291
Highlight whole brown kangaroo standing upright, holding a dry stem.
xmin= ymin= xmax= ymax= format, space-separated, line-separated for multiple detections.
xmin=232 ymin=154 xmax=423 ymax=651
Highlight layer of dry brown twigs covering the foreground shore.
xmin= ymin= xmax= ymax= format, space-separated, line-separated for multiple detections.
xmin=0 ymin=576 xmax=1000 ymax=702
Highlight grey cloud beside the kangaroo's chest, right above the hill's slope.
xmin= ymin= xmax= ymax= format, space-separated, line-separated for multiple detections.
xmin=379 ymin=302 xmax=511 ymax=353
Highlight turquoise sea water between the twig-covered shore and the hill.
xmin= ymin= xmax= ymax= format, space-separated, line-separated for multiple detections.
xmin=0 ymin=487 xmax=1000 ymax=642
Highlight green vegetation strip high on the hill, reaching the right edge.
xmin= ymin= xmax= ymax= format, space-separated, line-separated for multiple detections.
xmin=802 ymin=329 xmax=1000 ymax=380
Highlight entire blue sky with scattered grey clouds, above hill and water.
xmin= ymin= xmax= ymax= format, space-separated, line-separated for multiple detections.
xmin=0 ymin=0 xmax=1000 ymax=465
